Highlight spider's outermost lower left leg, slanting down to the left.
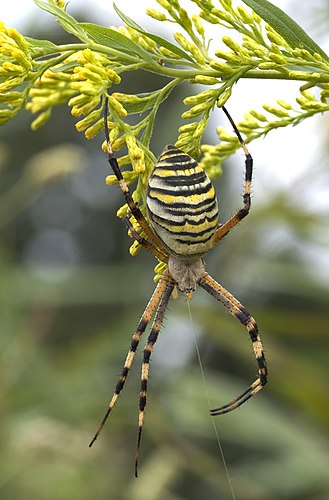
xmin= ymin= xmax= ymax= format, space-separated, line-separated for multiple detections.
xmin=89 ymin=273 xmax=172 ymax=447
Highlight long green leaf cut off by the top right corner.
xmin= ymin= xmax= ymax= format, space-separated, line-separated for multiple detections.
xmin=243 ymin=0 xmax=329 ymax=60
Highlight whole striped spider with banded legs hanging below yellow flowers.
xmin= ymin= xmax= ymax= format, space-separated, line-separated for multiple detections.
xmin=89 ymin=100 xmax=267 ymax=477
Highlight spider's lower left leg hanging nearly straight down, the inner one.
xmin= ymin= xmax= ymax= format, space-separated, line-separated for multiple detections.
xmin=135 ymin=280 xmax=175 ymax=477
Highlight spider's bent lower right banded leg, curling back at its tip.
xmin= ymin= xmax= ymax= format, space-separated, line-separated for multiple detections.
xmin=198 ymin=273 xmax=267 ymax=416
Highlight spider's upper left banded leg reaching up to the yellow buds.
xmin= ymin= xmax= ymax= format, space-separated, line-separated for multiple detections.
xmin=104 ymin=98 xmax=165 ymax=253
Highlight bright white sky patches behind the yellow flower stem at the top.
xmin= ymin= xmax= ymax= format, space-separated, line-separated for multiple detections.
xmin=0 ymin=0 xmax=329 ymax=269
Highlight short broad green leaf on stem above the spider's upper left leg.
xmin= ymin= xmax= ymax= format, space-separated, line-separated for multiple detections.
xmin=79 ymin=23 xmax=154 ymax=63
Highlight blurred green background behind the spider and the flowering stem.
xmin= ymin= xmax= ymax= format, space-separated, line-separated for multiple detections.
xmin=0 ymin=1 xmax=329 ymax=500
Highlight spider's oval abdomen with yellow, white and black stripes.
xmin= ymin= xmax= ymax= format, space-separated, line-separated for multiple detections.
xmin=147 ymin=146 xmax=218 ymax=257
